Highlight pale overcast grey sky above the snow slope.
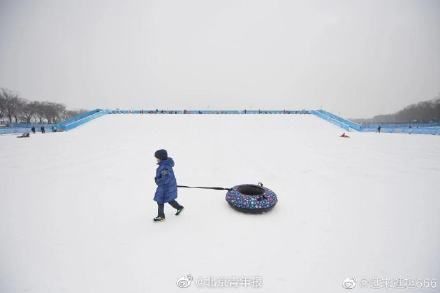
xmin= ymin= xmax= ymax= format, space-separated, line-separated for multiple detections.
xmin=0 ymin=0 xmax=440 ymax=117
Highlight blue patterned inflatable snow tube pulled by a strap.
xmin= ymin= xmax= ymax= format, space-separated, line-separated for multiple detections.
xmin=226 ymin=184 xmax=278 ymax=214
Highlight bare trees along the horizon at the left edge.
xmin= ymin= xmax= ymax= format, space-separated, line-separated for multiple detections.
xmin=0 ymin=88 xmax=86 ymax=123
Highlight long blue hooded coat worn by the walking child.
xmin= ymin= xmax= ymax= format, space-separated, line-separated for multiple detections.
xmin=154 ymin=158 xmax=177 ymax=204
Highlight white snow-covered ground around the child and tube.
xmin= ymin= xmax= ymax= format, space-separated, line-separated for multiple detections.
xmin=0 ymin=115 xmax=440 ymax=293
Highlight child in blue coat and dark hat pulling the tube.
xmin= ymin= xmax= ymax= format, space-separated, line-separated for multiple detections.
xmin=153 ymin=149 xmax=183 ymax=222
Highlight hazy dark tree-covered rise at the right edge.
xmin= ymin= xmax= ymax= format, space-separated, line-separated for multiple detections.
xmin=353 ymin=94 xmax=440 ymax=123
